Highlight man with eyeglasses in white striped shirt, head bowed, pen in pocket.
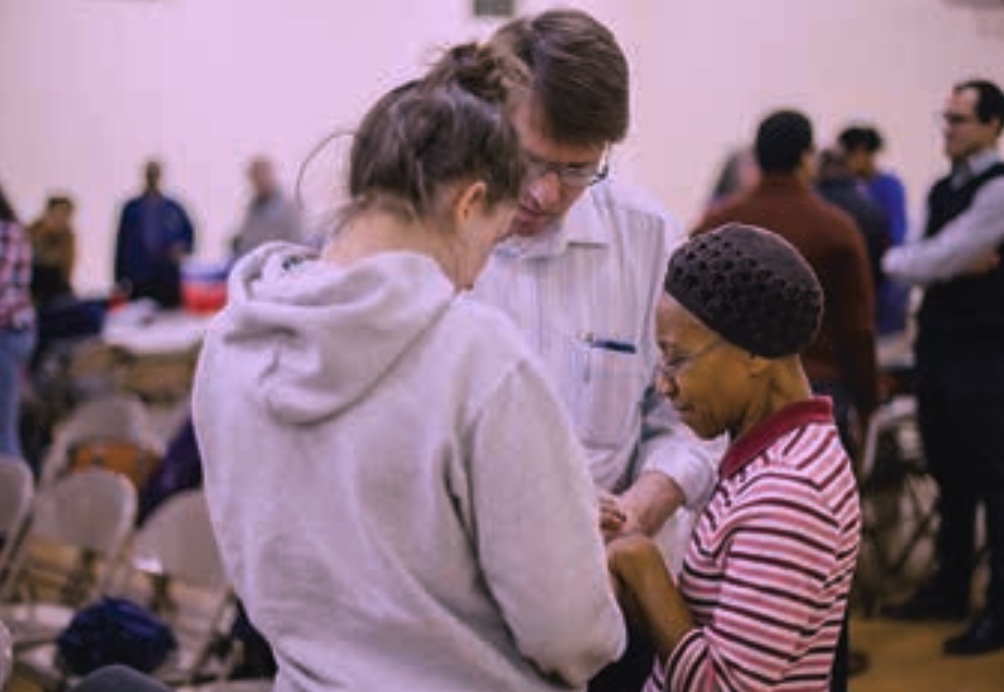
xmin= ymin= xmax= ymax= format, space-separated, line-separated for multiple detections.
xmin=474 ymin=10 xmax=723 ymax=690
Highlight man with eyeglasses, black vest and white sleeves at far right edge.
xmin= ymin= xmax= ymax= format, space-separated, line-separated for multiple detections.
xmin=883 ymin=79 xmax=1004 ymax=656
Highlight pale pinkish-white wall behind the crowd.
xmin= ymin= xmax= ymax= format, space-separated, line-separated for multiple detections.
xmin=0 ymin=0 xmax=1004 ymax=288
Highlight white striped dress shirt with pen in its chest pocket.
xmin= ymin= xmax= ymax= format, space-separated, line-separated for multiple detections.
xmin=474 ymin=181 xmax=724 ymax=565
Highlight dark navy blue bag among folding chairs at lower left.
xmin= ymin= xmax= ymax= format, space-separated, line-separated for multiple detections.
xmin=56 ymin=597 xmax=178 ymax=675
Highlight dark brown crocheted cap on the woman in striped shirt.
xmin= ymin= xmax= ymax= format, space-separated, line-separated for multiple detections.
xmin=666 ymin=224 xmax=823 ymax=358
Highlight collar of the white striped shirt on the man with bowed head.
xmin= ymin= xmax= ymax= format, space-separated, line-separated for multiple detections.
xmin=496 ymin=181 xmax=610 ymax=259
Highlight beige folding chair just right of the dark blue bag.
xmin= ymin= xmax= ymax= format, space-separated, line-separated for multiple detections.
xmin=18 ymin=490 xmax=234 ymax=689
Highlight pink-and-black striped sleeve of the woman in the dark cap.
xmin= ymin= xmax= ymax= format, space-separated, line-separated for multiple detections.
xmin=661 ymin=469 xmax=842 ymax=690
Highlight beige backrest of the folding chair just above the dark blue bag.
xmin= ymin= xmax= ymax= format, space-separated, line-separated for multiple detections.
xmin=0 ymin=469 xmax=137 ymax=605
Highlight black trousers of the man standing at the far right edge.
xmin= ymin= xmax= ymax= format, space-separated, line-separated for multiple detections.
xmin=917 ymin=354 xmax=1004 ymax=617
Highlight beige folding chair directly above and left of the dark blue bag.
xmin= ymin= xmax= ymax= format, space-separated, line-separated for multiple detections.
xmin=0 ymin=469 xmax=137 ymax=654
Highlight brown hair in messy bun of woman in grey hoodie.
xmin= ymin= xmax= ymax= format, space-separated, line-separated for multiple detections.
xmin=345 ymin=43 xmax=523 ymax=217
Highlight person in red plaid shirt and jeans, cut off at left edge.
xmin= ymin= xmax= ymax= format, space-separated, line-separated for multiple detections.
xmin=0 ymin=183 xmax=35 ymax=457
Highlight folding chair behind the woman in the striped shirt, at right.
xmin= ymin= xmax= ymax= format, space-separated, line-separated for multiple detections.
xmin=855 ymin=395 xmax=938 ymax=615
